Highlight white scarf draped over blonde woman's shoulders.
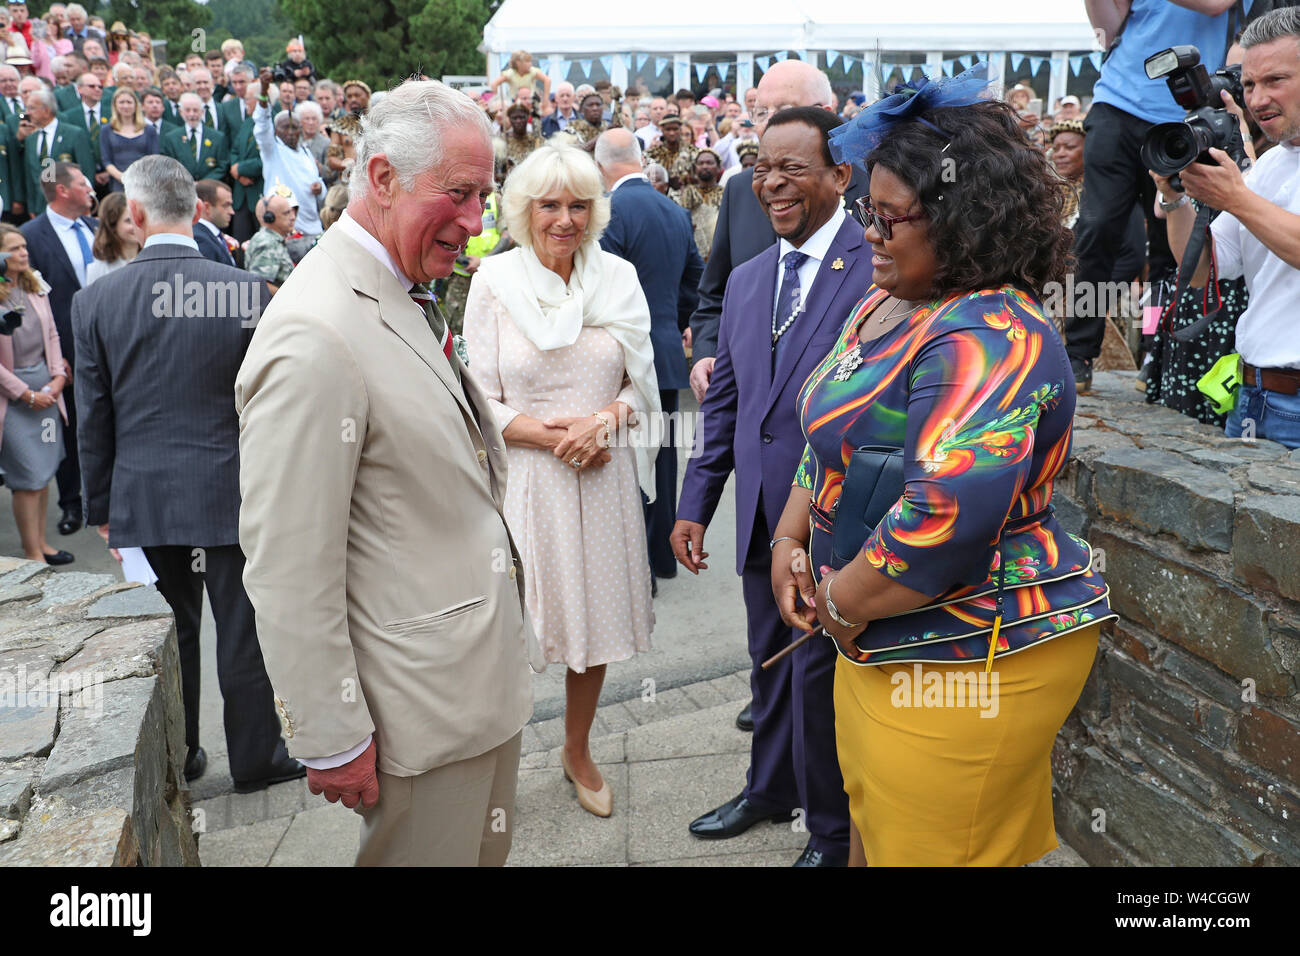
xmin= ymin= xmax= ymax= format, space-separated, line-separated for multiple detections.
xmin=478 ymin=241 xmax=662 ymax=501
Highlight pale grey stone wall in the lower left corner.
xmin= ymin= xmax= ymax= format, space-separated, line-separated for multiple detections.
xmin=0 ymin=558 xmax=199 ymax=866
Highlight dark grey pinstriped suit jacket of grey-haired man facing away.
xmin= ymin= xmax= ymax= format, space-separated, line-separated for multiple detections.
xmin=73 ymin=243 xmax=269 ymax=548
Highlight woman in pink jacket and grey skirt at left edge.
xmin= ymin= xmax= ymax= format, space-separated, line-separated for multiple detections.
xmin=0 ymin=222 xmax=73 ymax=564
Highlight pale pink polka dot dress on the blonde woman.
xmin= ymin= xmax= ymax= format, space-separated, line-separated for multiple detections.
xmin=464 ymin=281 xmax=654 ymax=672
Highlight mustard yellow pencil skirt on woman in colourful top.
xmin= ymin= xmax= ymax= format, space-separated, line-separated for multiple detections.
xmin=835 ymin=624 xmax=1100 ymax=866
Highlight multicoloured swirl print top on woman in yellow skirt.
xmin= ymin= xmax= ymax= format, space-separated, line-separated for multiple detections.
xmin=794 ymin=286 xmax=1117 ymax=665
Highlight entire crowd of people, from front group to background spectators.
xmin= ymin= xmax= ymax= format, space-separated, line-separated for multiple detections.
xmin=0 ymin=0 xmax=1300 ymax=866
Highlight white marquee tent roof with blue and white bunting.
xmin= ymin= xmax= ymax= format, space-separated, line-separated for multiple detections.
xmin=481 ymin=0 xmax=1100 ymax=100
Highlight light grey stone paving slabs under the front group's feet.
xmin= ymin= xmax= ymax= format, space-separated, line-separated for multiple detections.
xmin=195 ymin=671 xmax=1086 ymax=866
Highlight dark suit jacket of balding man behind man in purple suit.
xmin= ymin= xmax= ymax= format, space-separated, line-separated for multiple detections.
xmin=690 ymin=166 xmax=868 ymax=359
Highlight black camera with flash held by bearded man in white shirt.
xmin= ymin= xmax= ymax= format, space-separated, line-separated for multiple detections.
xmin=1141 ymin=44 xmax=1245 ymax=190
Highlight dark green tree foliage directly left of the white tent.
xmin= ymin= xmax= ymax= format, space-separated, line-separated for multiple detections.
xmin=280 ymin=0 xmax=491 ymax=90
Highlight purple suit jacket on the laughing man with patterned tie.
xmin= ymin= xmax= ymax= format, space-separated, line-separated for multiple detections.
xmin=677 ymin=216 xmax=871 ymax=574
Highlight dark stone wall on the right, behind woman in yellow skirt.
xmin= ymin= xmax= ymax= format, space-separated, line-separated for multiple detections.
xmin=1053 ymin=372 xmax=1300 ymax=866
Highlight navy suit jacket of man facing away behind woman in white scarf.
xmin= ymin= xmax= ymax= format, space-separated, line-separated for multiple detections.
xmin=601 ymin=179 xmax=705 ymax=389
